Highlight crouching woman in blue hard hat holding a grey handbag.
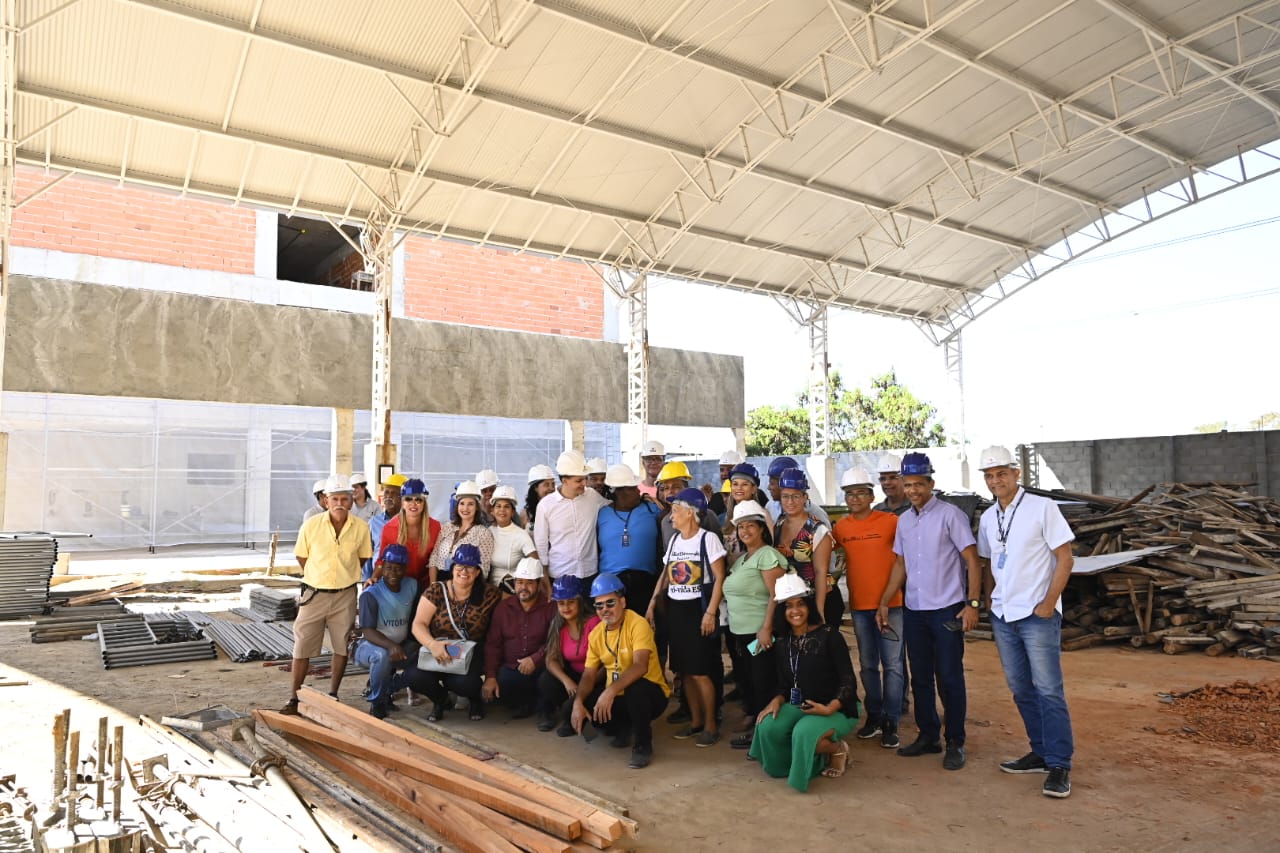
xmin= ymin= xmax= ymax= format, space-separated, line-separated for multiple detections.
xmin=394 ymin=545 xmax=502 ymax=722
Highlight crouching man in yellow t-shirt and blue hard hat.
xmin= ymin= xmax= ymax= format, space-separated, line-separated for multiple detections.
xmin=571 ymin=574 xmax=671 ymax=770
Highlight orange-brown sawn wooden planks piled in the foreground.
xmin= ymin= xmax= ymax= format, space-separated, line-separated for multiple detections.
xmin=253 ymin=689 xmax=636 ymax=853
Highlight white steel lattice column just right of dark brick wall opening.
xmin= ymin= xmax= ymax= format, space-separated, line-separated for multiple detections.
xmin=360 ymin=211 xmax=396 ymax=484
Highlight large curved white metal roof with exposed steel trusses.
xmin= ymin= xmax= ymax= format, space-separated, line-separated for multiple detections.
xmin=15 ymin=0 xmax=1280 ymax=341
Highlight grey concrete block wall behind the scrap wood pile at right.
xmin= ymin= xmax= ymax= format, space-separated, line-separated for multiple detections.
xmin=1036 ymin=430 xmax=1280 ymax=497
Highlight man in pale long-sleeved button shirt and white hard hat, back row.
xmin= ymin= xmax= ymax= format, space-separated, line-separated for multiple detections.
xmin=534 ymin=450 xmax=605 ymax=580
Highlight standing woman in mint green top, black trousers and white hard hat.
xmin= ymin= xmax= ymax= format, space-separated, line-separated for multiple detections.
xmin=724 ymin=501 xmax=787 ymax=749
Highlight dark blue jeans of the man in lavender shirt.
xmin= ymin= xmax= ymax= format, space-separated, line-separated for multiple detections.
xmin=902 ymin=602 xmax=969 ymax=747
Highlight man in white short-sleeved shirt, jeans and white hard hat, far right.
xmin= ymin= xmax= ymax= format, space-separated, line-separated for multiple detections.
xmin=978 ymin=447 xmax=1075 ymax=799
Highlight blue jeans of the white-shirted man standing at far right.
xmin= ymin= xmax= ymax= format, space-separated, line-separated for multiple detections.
xmin=991 ymin=612 xmax=1074 ymax=770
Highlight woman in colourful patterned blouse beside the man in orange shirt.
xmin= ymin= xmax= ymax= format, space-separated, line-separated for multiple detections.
xmin=773 ymin=467 xmax=845 ymax=630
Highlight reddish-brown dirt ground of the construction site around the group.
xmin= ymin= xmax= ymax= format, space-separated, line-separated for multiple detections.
xmin=0 ymin=604 xmax=1280 ymax=850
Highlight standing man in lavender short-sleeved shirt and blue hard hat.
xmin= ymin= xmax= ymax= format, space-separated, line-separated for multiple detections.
xmin=876 ymin=453 xmax=982 ymax=770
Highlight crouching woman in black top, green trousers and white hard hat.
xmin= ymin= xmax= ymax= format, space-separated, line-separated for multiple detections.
xmin=750 ymin=575 xmax=858 ymax=793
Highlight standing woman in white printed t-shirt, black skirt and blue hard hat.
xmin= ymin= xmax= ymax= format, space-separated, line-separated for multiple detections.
xmin=645 ymin=488 xmax=724 ymax=747
